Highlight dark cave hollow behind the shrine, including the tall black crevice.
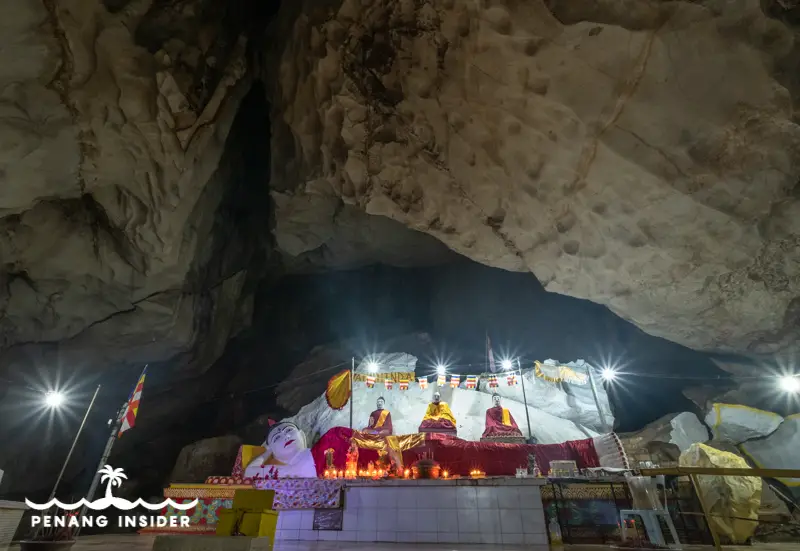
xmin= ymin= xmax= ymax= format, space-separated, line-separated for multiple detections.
xmin=0 ymin=66 xmax=726 ymax=504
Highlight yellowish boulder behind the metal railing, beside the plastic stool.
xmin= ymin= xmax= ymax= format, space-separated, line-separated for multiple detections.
xmin=679 ymin=444 xmax=761 ymax=544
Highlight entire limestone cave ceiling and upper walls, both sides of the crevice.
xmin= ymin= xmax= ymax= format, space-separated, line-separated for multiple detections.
xmin=0 ymin=0 xmax=800 ymax=384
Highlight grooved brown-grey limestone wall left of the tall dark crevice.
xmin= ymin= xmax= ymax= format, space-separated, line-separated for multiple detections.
xmin=0 ymin=0 xmax=255 ymax=376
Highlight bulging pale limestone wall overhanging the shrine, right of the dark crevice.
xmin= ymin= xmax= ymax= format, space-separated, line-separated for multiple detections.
xmin=267 ymin=0 xmax=800 ymax=353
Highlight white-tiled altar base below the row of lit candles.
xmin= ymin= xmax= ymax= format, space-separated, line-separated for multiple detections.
xmin=275 ymin=477 xmax=548 ymax=549
